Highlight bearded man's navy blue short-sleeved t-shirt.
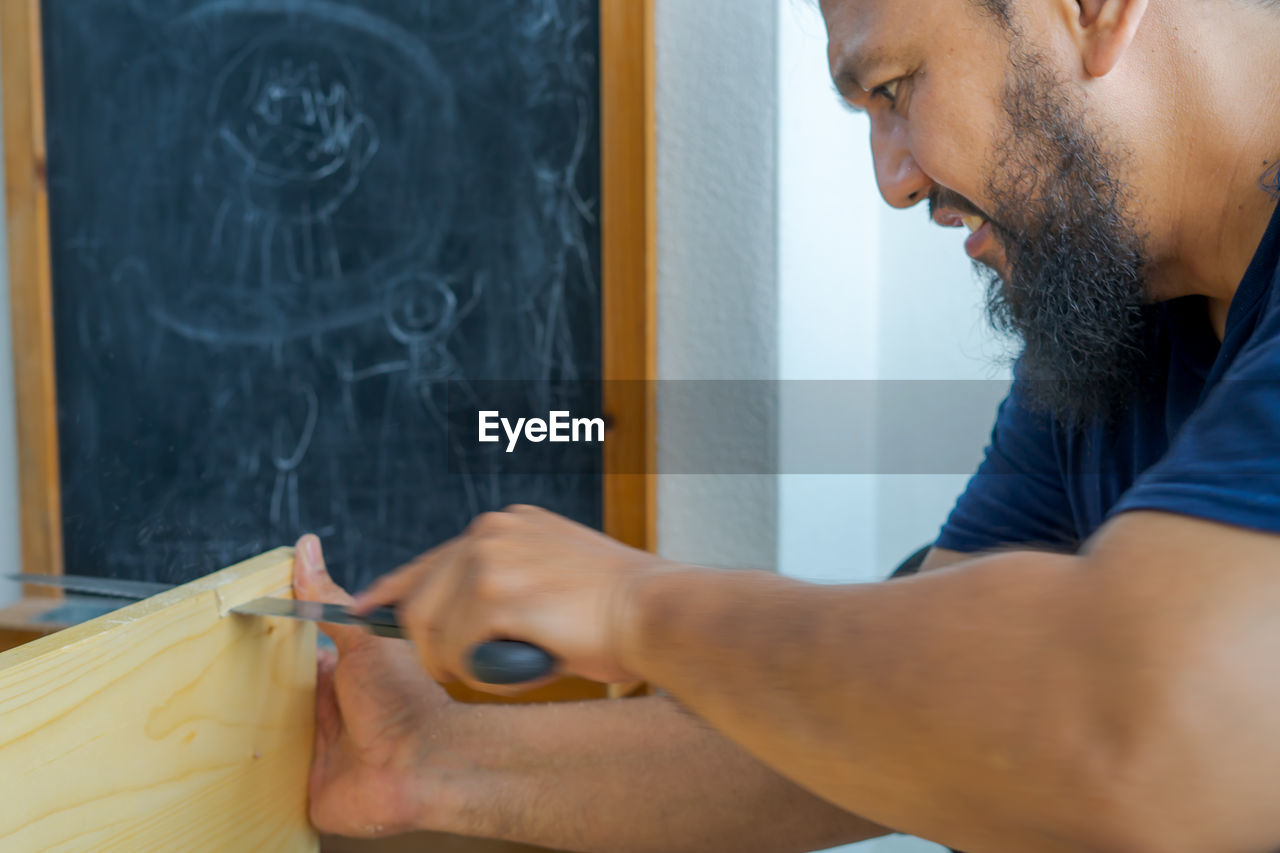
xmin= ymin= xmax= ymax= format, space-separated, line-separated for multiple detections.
xmin=936 ymin=195 xmax=1280 ymax=553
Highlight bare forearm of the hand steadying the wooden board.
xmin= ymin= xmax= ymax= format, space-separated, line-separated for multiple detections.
xmin=433 ymin=697 xmax=886 ymax=853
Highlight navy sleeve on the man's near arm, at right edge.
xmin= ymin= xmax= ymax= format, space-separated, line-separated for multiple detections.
xmin=1111 ymin=322 xmax=1280 ymax=533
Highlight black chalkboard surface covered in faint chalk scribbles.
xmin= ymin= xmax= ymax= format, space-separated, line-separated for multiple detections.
xmin=42 ymin=0 xmax=602 ymax=587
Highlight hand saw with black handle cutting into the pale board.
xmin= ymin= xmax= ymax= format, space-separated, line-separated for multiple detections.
xmin=8 ymin=574 xmax=556 ymax=684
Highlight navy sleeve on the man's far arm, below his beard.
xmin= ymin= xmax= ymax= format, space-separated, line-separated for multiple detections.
xmin=934 ymin=380 xmax=1078 ymax=553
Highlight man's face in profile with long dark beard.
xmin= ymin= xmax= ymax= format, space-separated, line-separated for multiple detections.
xmin=822 ymin=0 xmax=1147 ymax=420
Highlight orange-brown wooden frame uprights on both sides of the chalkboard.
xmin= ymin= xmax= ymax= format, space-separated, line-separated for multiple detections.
xmin=0 ymin=0 xmax=657 ymax=578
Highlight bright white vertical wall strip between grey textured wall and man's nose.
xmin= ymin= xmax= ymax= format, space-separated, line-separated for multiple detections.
xmin=776 ymin=0 xmax=881 ymax=580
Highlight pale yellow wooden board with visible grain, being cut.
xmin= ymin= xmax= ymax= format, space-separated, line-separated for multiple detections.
xmin=0 ymin=548 xmax=317 ymax=853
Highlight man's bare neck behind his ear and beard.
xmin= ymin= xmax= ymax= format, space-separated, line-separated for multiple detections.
xmin=1153 ymin=0 xmax=1280 ymax=338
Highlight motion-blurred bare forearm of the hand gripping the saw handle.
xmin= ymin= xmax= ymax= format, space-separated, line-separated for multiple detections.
xmin=627 ymin=553 xmax=1126 ymax=850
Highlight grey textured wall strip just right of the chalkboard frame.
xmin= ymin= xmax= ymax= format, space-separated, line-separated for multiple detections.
xmin=655 ymin=0 xmax=778 ymax=569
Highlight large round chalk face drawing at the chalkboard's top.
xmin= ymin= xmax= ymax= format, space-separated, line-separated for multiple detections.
xmin=143 ymin=0 xmax=460 ymax=345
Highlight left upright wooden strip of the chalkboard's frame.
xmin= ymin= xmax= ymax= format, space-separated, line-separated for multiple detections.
xmin=0 ymin=0 xmax=63 ymax=578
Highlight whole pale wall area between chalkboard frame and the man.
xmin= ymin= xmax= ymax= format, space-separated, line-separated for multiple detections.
xmin=657 ymin=0 xmax=989 ymax=591
